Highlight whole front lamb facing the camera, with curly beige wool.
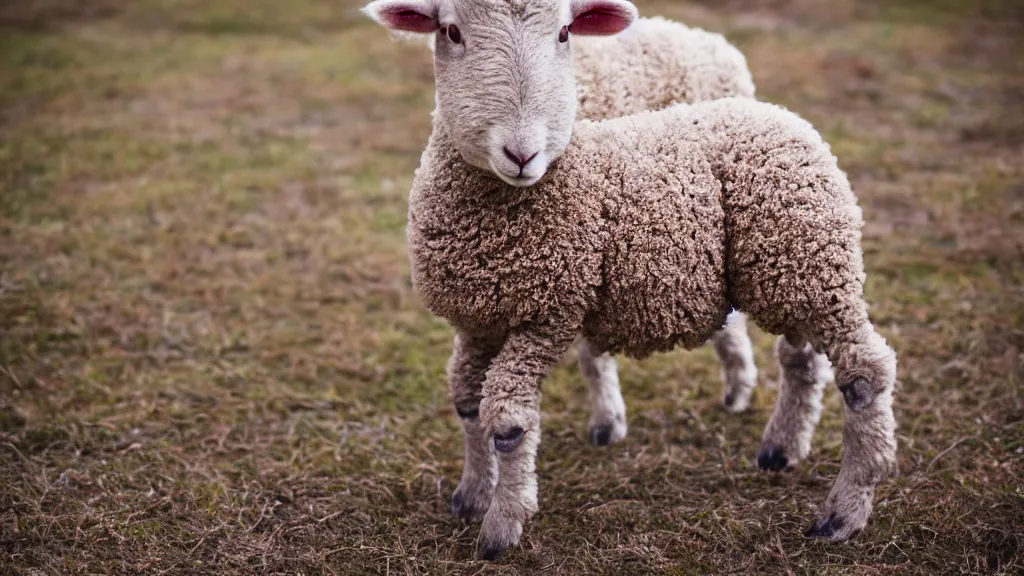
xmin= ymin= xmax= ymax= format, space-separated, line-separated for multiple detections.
xmin=366 ymin=0 xmax=896 ymax=559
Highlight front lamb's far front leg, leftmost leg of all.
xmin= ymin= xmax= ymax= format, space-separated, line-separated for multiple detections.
xmin=447 ymin=334 xmax=502 ymax=521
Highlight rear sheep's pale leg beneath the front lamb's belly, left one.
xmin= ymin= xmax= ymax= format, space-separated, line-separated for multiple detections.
xmin=579 ymin=339 xmax=627 ymax=446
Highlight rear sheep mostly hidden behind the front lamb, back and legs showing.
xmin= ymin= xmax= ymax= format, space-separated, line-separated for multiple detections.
xmin=573 ymin=17 xmax=758 ymax=438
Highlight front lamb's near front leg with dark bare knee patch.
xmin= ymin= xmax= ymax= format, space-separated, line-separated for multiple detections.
xmin=478 ymin=327 xmax=575 ymax=560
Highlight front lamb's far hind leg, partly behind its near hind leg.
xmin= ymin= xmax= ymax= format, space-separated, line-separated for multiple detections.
xmin=758 ymin=336 xmax=833 ymax=470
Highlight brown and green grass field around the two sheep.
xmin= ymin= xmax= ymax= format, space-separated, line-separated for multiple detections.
xmin=0 ymin=0 xmax=1024 ymax=575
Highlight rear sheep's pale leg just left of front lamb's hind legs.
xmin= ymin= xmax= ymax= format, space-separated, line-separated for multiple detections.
xmin=713 ymin=311 xmax=758 ymax=412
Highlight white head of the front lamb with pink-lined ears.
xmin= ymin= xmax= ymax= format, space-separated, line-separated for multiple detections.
xmin=364 ymin=0 xmax=636 ymax=187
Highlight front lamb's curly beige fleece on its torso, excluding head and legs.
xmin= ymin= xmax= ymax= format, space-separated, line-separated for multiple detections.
xmin=409 ymin=98 xmax=867 ymax=357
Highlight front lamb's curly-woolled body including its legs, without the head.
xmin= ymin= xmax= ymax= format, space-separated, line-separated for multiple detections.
xmin=409 ymin=98 xmax=896 ymax=556
